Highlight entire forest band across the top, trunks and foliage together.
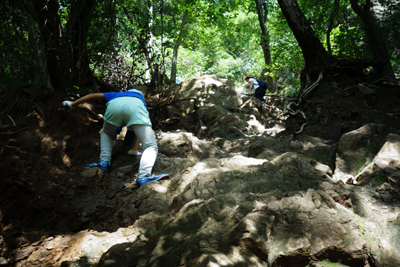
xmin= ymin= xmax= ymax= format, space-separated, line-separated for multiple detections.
xmin=0 ymin=0 xmax=400 ymax=96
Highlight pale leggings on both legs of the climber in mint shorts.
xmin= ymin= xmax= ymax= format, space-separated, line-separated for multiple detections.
xmin=100 ymin=122 xmax=158 ymax=177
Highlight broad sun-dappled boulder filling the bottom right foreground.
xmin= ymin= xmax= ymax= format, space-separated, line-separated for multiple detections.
xmin=93 ymin=153 xmax=400 ymax=267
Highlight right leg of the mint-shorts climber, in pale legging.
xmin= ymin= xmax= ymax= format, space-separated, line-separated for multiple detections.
xmin=128 ymin=124 xmax=158 ymax=177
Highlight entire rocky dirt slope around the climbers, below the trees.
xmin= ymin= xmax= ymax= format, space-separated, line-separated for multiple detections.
xmin=0 ymin=76 xmax=400 ymax=267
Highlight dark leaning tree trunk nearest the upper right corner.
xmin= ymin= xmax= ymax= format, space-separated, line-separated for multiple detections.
xmin=350 ymin=0 xmax=395 ymax=80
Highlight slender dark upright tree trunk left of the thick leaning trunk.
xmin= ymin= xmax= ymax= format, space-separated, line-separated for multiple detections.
xmin=255 ymin=0 xmax=273 ymax=89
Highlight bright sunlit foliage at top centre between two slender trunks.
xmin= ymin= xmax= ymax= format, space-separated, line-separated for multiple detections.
xmin=166 ymin=5 xmax=263 ymax=83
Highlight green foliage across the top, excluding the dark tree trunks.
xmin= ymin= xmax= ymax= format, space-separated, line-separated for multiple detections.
xmin=0 ymin=0 xmax=400 ymax=97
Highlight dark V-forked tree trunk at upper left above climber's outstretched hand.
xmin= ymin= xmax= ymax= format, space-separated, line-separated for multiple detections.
xmin=25 ymin=0 xmax=96 ymax=90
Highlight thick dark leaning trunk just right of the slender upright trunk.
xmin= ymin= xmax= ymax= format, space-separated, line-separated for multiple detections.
xmin=278 ymin=0 xmax=331 ymax=90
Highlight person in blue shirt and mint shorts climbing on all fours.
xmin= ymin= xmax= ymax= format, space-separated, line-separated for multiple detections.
xmin=63 ymin=89 xmax=169 ymax=186
